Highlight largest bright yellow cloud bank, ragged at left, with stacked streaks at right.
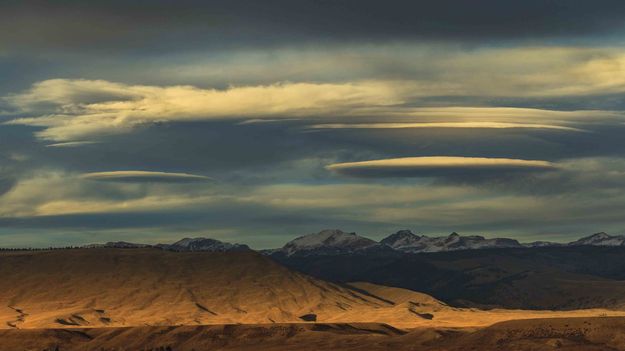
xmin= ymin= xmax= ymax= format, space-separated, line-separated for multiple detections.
xmin=5 ymin=79 xmax=623 ymax=142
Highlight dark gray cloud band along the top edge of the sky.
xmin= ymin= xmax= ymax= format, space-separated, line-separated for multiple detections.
xmin=0 ymin=0 xmax=625 ymax=51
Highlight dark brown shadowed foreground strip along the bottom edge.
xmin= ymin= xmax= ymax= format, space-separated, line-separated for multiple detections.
xmin=0 ymin=317 xmax=625 ymax=351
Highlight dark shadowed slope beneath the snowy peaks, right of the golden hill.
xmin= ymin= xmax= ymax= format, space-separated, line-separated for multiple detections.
xmin=275 ymin=246 xmax=625 ymax=310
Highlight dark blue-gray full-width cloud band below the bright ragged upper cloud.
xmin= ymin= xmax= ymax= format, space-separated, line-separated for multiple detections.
xmin=0 ymin=116 xmax=625 ymax=184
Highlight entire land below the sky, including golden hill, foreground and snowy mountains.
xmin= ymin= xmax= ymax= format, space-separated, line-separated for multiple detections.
xmin=6 ymin=230 xmax=625 ymax=351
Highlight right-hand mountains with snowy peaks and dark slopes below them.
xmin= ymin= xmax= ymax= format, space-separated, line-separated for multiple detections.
xmin=268 ymin=231 xmax=625 ymax=310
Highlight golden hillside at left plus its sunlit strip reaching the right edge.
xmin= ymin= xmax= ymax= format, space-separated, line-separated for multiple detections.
xmin=0 ymin=248 xmax=625 ymax=329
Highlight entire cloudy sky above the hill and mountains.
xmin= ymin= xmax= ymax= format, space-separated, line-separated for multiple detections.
xmin=0 ymin=0 xmax=625 ymax=248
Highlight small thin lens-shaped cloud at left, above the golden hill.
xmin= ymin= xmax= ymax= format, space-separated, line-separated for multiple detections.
xmin=81 ymin=171 xmax=213 ymax=183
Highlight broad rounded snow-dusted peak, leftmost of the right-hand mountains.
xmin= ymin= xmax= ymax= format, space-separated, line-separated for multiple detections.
xmin=280 ymin=229 xmax=379 ymax=256
